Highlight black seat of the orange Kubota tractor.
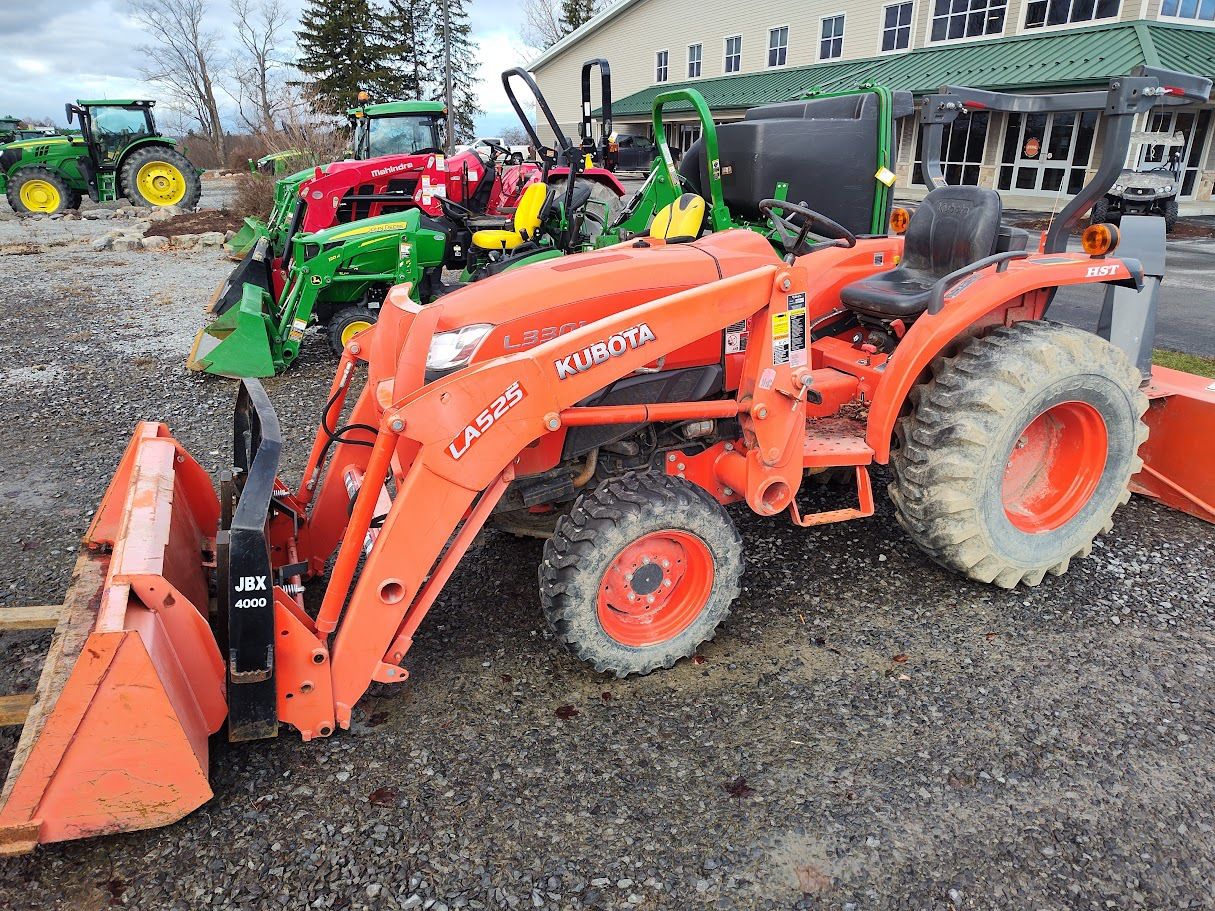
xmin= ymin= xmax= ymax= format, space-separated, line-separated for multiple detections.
xmin=840 ymin=187 xmax=1006 ymax=321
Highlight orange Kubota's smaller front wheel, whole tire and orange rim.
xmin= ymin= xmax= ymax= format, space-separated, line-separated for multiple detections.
xmin=539 ymin=473 xmax=742 ymax=678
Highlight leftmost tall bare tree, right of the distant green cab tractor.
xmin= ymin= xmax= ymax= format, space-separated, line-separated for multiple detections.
xmin=129 ymin=0 xmax=227 ymax=160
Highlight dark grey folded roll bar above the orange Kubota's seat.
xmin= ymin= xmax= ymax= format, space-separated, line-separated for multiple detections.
xmin=920 ymin=66 xmax=1211 ymax=253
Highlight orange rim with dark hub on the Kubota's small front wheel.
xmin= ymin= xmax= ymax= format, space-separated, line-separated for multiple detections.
xmin=598 ymin=530 xmax=713 ymax=647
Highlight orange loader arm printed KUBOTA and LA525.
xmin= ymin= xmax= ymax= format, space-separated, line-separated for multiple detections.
xmin=311 ymin=265 xmax=804 ymax=726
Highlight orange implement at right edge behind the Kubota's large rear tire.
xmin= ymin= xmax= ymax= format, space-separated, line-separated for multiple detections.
xmin=1131 ymin=367 xmax=1215 ymax=522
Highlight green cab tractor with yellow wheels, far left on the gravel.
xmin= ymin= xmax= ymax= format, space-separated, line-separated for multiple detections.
xmin=0 ymin=100 xmax=202 ymax=215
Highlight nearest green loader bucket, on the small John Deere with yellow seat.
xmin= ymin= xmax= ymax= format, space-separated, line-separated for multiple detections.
xmin=186 ymin=283 xmax=282 ymax=377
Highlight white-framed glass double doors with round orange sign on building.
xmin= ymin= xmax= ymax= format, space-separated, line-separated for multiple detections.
xmin=999 ymin=111 xmax=1097 ymax=194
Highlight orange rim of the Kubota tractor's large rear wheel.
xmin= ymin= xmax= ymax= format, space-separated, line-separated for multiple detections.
xmin=1002 ymin=402 xmax=1109 ymax=534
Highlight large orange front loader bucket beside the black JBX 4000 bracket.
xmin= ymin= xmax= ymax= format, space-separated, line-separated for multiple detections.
xmin=0 ymin=423 xmax=226 ymax=854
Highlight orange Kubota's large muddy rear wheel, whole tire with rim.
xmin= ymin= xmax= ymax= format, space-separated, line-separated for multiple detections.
xmin=889 ymin=321 xmax=1147 ymax=588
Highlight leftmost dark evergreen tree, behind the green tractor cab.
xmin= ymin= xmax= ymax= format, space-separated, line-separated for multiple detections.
xmin=295 ymin=0 xmax=399 ymax=114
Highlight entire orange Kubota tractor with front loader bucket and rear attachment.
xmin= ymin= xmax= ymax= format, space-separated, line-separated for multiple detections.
xmin=0 ymin=69 xmax=1215 ymax=853
